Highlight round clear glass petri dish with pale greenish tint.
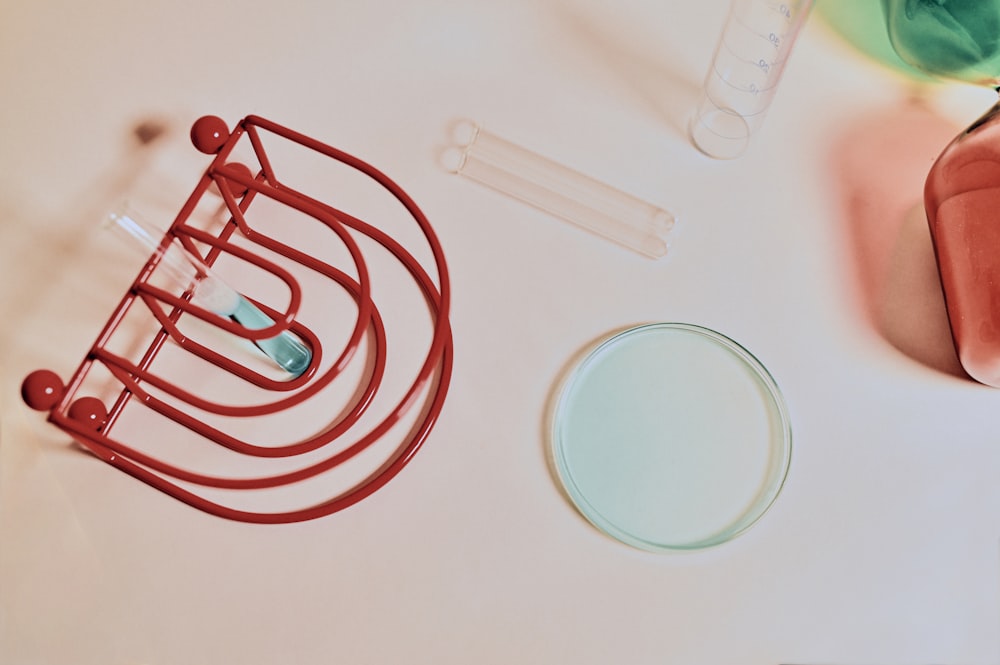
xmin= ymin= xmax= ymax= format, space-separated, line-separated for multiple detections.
xmin=552 ymin=323 xmax=792 ymax=551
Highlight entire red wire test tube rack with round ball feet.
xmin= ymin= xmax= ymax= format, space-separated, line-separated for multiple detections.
xmin=22 ymin=116 xmax=452 ymax=523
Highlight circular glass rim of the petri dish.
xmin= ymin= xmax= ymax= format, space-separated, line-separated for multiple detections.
xmin=549 ymin=322 xmax=792 ymax=552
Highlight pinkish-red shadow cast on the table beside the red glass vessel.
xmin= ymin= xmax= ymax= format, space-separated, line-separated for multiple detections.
xmin=831 ymin=100 xmax=966 ymax=377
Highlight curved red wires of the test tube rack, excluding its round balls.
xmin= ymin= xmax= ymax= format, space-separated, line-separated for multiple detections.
xmin=36 ymin=116 xmax=453 ymax=523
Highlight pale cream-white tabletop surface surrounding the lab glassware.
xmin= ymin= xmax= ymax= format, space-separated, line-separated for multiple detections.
xmin=0 ymin=0 xmax=1000 ymax=665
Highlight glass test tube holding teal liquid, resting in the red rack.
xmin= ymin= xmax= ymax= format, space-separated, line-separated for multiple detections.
xmin=108 ymin=213 xmax=312 ymax=376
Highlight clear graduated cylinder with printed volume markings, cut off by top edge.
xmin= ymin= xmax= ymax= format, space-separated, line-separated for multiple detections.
xmin=689 ymin=0 xmax=813 ymax=159
